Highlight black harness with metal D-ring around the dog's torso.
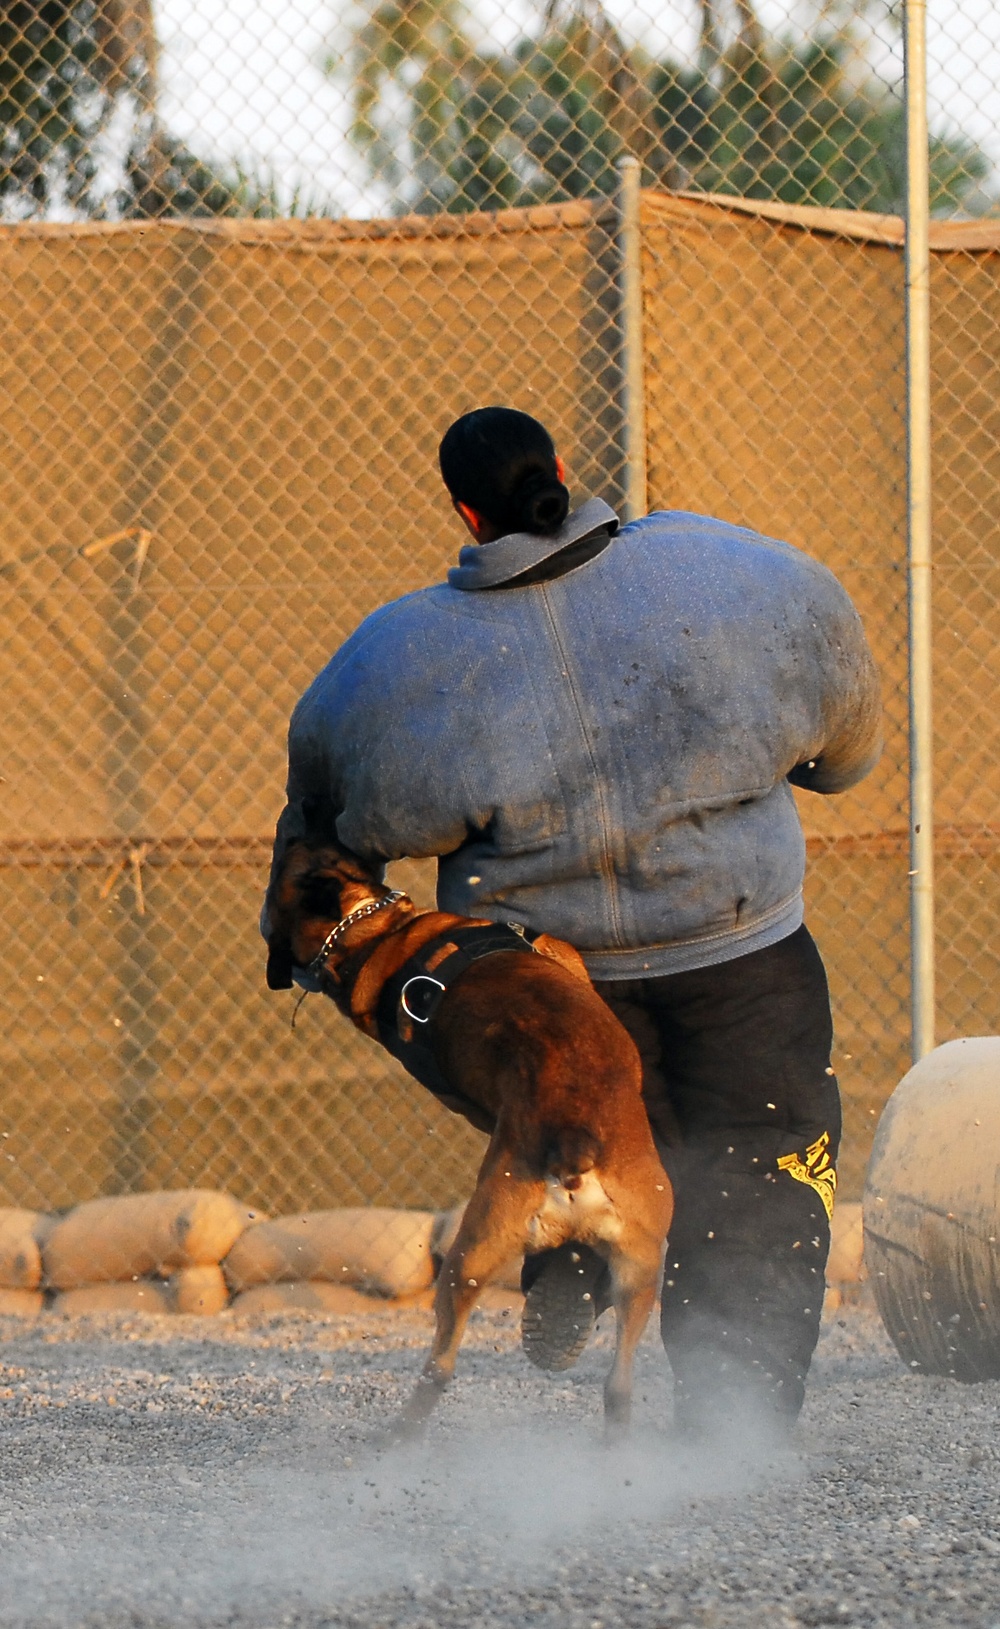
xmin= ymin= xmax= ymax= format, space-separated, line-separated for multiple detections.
xmin=375 ymin=922 xmax=539 ymax=1124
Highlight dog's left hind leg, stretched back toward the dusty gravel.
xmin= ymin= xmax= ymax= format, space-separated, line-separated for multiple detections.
xmin=395 ymin=1175 xmax=539 ymax=1434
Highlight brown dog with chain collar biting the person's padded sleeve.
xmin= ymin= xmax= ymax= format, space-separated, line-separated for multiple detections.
xmin=269 ymin=844 xmax=673 ymax=1429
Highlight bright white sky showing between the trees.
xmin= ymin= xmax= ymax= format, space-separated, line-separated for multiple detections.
xmin=155 ymin=0 xmax=1000 ymax=215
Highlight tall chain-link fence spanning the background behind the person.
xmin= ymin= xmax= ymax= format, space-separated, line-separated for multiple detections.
xmin=0 ymin=0 xmax=1000 ymax=1210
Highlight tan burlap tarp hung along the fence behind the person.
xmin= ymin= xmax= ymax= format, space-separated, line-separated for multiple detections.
xmin=0 ymin=194 xmax=1000 ymax=1209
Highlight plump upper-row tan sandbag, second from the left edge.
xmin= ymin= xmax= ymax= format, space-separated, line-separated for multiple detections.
xmin=42 ymin=1188 xmax=259 ymax=1290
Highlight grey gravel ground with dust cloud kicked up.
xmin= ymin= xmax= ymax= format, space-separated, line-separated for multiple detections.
xmin=0 ymin=1306 xmax=1000 ymax=1629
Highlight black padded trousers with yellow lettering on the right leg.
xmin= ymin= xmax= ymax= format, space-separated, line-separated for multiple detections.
xmin=596 ymin=927 xmax=840 ymax=1430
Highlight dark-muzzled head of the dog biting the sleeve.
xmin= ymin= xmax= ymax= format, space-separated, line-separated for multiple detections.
xmin=267 ymin=841 xmax=375 ymax=990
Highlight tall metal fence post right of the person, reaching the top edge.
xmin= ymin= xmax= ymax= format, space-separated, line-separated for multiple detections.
xmin=904 ymin=0 xmax=935 ymax=1062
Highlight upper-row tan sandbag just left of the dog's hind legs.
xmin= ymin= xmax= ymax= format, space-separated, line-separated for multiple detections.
xmin=223 ymin=1207 xmax=435 ymax=1298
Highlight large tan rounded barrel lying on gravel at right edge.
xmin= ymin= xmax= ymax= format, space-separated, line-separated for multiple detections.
xmin=863 ymin=1036 xmax=1000 ymax=1380
